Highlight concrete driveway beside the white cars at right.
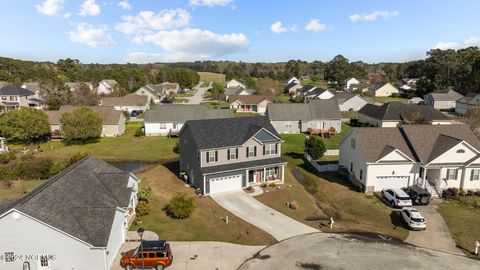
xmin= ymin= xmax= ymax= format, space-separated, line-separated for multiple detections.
xmin=405 ymin=204 xmax=464 ymax=254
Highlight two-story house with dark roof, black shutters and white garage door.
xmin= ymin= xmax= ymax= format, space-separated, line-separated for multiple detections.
xmin=180 ymin=117 xmax=287 ymax=195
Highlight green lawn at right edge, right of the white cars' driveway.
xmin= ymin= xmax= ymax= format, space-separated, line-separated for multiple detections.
xmin=438 ymin=196 xmax=480 ymax=254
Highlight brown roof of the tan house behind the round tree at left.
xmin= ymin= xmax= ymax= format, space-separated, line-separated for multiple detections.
xmin=45 ymin=105 xmax=123 ymax=125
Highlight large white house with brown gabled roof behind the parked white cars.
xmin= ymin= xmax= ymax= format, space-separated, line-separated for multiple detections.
xmin=339 ymin=125 xmax=480 ymax=196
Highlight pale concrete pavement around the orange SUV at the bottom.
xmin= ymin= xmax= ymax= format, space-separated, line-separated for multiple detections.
xmin=110 ymin=242 xmax=265 ymax=270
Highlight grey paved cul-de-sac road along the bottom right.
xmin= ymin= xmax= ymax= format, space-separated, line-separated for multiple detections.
xmin=239 ymin=233 xmax=480 ymax=270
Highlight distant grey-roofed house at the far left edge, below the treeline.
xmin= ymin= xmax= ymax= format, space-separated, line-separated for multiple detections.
xmin=0 ymin=84 xmax=43 ymax=113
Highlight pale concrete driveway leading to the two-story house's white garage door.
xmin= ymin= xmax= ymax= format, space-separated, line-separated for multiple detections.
xmin=211 ymin=190 xmax=318 ymax=241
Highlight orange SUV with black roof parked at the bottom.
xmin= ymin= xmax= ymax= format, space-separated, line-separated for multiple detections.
xmin=120 ymin=241 xmax=173 ymax=270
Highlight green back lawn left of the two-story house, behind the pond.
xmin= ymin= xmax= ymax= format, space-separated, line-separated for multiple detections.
xmin=31 ymin=123 xmax=178 ymax=162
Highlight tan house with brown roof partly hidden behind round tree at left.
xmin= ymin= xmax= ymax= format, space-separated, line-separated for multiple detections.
xmin=45 ymin=106 xmax=125 ymax=137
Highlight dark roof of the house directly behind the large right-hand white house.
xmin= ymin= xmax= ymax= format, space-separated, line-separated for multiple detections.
xmin=358 ymin=102 xmax=449 ymax=121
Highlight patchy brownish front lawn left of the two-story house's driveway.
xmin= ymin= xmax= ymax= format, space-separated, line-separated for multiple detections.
xmin=130 ymin=162 xmax=276 ymax=245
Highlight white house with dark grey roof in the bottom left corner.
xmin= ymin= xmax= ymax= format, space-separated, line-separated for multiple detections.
xmin=0 ymin=157 xmax=138 ymax=270
